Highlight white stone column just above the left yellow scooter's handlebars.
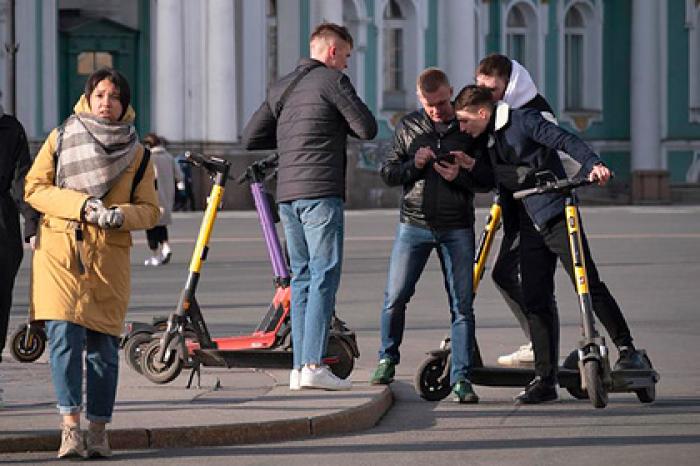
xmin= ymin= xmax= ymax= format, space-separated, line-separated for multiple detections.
xmin=205 ymin=0 xmax=238 ymax=142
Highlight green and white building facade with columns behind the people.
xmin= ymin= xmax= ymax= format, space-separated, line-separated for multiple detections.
xmin=0 ymin=0 xmax=700 ymax=204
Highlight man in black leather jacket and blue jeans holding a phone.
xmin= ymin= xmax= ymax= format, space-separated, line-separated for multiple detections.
xmin=370 ymin=68 xmax=490 ymax=403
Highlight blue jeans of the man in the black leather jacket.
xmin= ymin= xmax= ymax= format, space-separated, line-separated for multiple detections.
xmin=379 ymin=223 xmax=474 ymax=384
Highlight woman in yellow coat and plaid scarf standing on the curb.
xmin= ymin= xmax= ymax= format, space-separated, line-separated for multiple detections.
xmin=25 ymin=68 xmax=160 ymax=458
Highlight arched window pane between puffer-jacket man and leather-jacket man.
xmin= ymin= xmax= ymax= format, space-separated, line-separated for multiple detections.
xmin=383 ymin=0 xmax=406 ymax=109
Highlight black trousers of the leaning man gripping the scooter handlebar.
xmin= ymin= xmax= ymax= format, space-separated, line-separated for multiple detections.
xmin=519 ymin=206 xmax=632 ymax=379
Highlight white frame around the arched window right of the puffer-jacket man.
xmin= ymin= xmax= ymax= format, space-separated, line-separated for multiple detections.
xmin=374 ymin=0 xmax=428 ymax=117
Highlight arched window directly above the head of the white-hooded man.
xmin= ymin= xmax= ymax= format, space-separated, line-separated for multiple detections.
xmin=505 ymin=2 xmax=539 ymax=82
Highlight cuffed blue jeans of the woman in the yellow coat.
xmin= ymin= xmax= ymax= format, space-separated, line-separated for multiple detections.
xmin=46 ymin=320 xmax=119 ymax=422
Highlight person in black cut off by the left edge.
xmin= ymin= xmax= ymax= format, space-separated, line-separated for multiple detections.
xmin=0 ymin=98 xmax=31 ymax=407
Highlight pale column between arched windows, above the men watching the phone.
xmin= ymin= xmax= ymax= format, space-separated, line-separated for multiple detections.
xmin=438 ymin=0 xmax=476 ymax=92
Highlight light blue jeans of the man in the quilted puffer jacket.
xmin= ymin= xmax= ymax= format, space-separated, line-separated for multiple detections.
xmin=279 ymin=197 xmax=344 ymax=369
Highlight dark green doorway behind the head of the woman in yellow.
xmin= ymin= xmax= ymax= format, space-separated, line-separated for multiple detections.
xmin=60 ymin=18 xmax=142 ymax=132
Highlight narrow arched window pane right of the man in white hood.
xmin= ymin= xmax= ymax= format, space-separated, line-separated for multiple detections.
xmin=564 ymin=6 xmax=586 ymax=110
